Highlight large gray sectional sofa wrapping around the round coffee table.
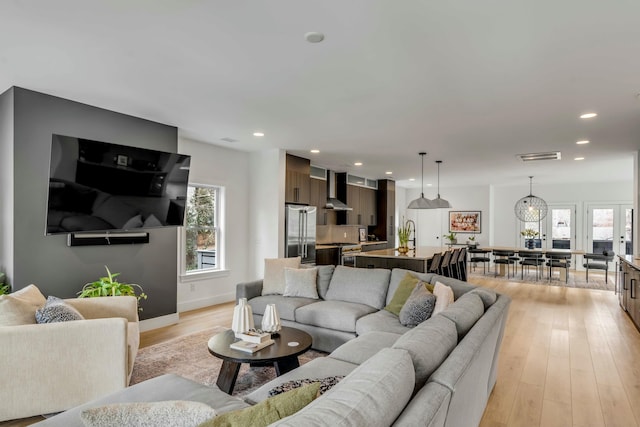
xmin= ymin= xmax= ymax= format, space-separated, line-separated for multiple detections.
xmin=38 ymin=267 xmax=511 ymax=427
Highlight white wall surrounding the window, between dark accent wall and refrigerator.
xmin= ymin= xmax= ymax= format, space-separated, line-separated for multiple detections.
xmin=178 ymin=137 xmax=253 ymax=312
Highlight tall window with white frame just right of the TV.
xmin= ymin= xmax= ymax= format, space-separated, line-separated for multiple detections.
xmin=184 ymin=185 xmax=223 ymax=273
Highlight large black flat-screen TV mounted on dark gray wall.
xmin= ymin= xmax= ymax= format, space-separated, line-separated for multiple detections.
xmin=46 ymin=134 xmax=191 ymax=235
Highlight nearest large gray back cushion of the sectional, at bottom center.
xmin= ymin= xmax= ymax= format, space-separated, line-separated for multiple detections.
xmin=274 ymin=348 xmax=415 ymax=427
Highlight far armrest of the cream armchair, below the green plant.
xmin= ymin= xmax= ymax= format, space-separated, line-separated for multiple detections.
xmin=64 ymin=296 xmax=138 ymax=322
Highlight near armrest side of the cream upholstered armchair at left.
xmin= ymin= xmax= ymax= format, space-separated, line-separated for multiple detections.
xmin=0 ymin=317 xmax=128 ymax=421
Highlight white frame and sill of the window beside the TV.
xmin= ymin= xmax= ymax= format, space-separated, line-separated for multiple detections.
xmin=178 ymin=183 xmax=229 ymax=282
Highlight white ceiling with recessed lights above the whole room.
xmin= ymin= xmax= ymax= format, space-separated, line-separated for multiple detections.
xmin=0 ymin=0 xmax=640 ymax=188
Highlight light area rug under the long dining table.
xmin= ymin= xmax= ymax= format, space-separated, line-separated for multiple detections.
xmin=467 ymin=266 xmax=615 ymax=291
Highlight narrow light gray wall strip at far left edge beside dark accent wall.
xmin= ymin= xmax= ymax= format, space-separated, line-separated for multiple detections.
xmin=0 ymin=88 xmax=13 ymax=283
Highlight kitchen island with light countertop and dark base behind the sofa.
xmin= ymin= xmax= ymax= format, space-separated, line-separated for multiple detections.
xmin=356 ymin=246 xmax=448 ymax=273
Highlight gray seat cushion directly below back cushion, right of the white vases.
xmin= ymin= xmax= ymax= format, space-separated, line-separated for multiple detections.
xmin=295 ymin=301 xmax=376 ymax=332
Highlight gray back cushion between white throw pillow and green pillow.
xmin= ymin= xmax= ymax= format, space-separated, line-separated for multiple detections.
xmin=326 ymin=265 xmax=391 ymax=310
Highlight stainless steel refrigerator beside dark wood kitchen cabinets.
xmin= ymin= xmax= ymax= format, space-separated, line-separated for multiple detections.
xmin=284 ymin=205 xmax=318 ymax=264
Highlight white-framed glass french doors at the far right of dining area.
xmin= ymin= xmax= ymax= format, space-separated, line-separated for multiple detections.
xmin=586 ymin=204 xmax=633 ymax=255
